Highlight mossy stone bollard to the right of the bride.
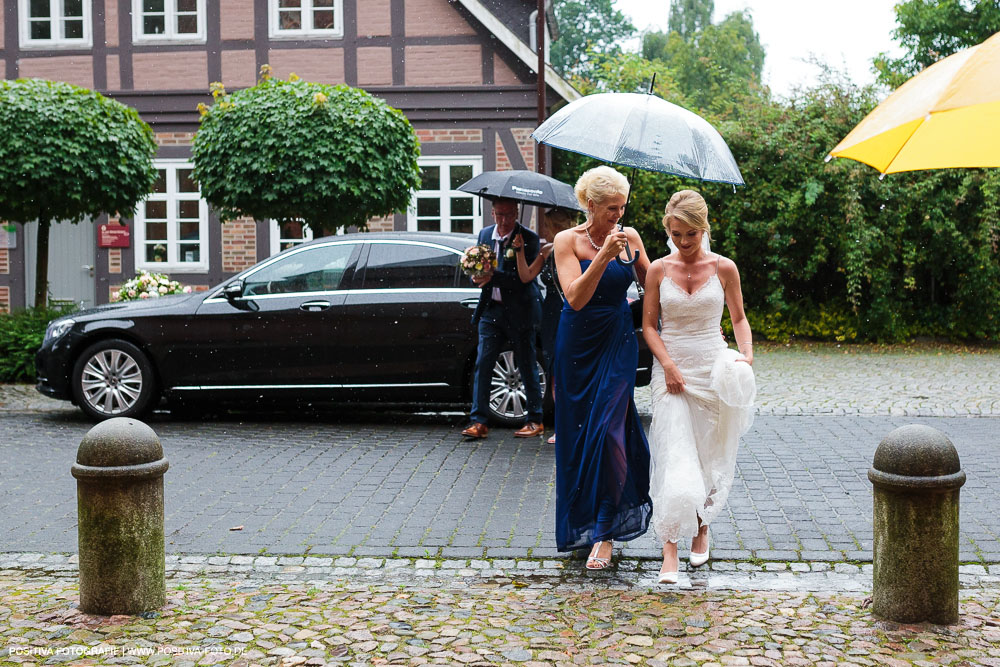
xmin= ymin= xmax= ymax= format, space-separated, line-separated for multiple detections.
xmin=868 ymin=425 xmax=965 ymax=625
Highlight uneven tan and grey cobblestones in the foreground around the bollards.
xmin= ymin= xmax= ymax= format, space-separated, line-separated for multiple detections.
xmin=0 ymin=566 xmax=1000 ymax=667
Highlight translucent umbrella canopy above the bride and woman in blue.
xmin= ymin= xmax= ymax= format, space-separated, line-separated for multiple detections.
xmin=531 ymin=93 xmax=743 ymax=185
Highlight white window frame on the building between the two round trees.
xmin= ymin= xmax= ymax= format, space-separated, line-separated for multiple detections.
xmin=134 ymin=159 xmax=209 ymax=273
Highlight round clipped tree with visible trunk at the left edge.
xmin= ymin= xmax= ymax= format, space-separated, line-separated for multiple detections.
xmin=0 ymin=79 xmax=156 ymax=307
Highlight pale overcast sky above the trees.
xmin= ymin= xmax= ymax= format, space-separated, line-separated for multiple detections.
xmin=614 ymin=0 xmax=899 ymax=95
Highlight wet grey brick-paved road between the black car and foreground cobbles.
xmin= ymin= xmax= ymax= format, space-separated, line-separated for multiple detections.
xmin=0 ymin=410 xmax=1000 ymax=563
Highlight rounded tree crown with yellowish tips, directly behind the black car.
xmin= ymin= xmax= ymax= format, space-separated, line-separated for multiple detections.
xmin=192 ymin=74 xmax=420 ymax=233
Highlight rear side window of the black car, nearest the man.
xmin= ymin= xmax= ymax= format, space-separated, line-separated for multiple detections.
xmin=364 ymin=243 xmax=458 ymax=289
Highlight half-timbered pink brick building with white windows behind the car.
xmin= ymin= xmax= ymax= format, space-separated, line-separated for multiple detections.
xmin=0 ymin=0 xmax=578 ymax=311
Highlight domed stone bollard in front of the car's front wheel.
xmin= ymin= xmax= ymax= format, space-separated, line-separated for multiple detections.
xmin=73 ymin=417 xmax=168 ymax=616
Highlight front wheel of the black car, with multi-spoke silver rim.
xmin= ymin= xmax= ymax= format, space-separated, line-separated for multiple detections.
xmin=73 ymin=339 xmax=156 ymax=421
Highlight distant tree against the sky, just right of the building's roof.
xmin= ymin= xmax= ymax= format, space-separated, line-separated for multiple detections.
xmin=549 ymin=0 xmax=635 ymax=74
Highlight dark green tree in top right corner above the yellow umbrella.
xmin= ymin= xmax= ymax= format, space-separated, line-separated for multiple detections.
xmin=874 ymin=0 xmax=1000 ymax=88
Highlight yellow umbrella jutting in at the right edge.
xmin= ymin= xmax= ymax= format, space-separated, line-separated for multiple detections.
xmin=827 ymin=33 xmax=1000 ymax=174
